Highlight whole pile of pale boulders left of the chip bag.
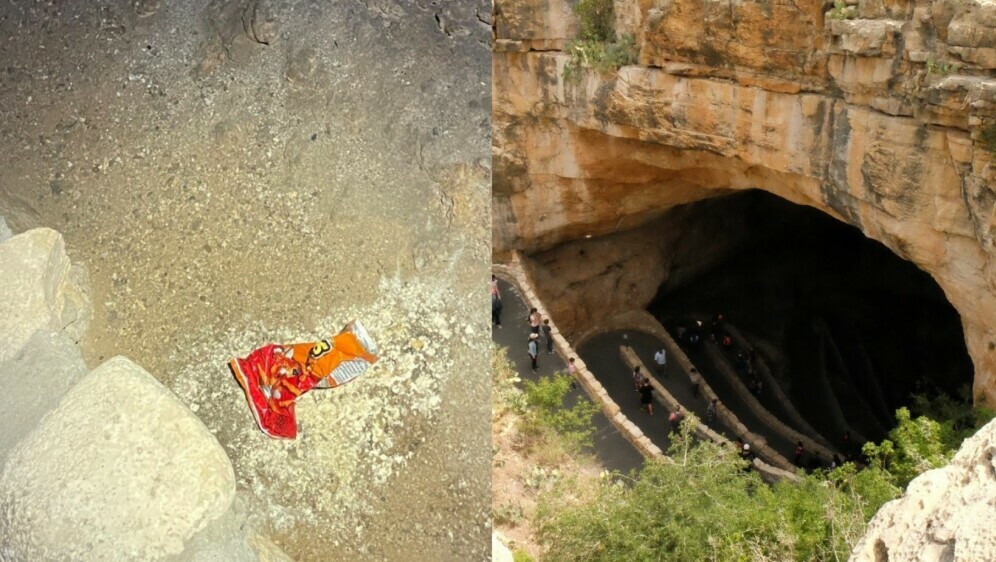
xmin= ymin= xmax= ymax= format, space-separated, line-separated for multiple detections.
xmin=0 ymin=225 xmax=289 ymax=562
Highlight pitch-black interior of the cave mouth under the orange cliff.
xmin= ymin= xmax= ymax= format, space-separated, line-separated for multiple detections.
xmin=648 ymin=190 xmax=973 ymax=442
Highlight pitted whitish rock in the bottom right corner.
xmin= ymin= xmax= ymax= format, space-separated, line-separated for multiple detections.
xmin=851 ymin=416 xmax=996 ymax=562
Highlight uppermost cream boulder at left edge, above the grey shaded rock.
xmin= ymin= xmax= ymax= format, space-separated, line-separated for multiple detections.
xmin=0 ymin=228 xmax=90 ymax=361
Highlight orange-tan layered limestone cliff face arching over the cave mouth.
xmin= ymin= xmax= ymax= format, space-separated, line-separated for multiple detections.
xmin=493 ymin=0 xmax=996 ymax=403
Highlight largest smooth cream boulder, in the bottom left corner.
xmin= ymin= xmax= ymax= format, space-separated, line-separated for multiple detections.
xmin=0 ymin=357 xmax=235 ymax=561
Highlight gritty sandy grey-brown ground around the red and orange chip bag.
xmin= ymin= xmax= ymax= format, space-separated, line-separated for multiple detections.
xmin=0 ymin=0 xmax=491 ymax=560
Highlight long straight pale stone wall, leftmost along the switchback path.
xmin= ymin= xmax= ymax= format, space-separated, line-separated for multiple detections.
xmin=492 ymin=252 xmax=664 ymax=458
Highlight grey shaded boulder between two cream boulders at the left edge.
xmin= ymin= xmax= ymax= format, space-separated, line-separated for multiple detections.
xmin=0 ymin=331 xmax=87 ymax=468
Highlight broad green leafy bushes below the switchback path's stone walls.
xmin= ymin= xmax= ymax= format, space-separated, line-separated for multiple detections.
xmin=539 ymin=424 xmax=898 ymax=561
